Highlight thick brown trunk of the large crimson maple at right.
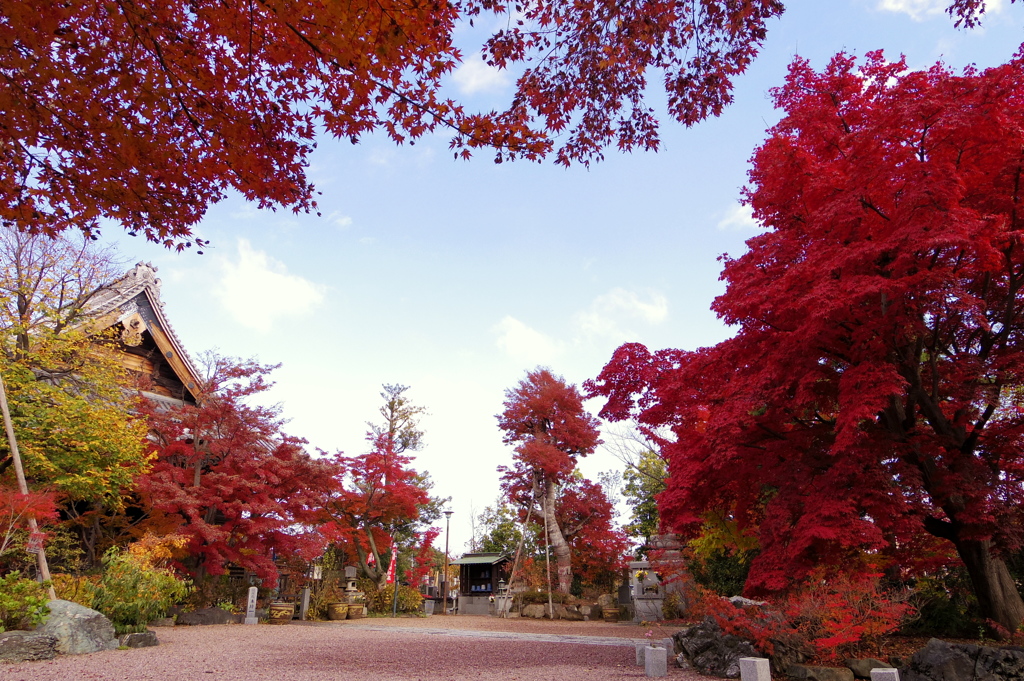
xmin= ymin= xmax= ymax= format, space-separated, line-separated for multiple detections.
xmin=953 ymin=540 xmax=1024 ymax=633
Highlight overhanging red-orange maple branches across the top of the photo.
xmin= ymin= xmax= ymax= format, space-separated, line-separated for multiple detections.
xmin=0 ymin=0 xmax=782 ymax=248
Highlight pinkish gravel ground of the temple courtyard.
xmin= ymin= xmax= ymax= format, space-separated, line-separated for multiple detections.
xmin=0 ymin=615 xmax=701 ymax=681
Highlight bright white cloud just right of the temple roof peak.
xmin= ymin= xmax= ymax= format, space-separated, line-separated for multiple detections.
xmin=215 ymin=239 xmax=325 ymax=332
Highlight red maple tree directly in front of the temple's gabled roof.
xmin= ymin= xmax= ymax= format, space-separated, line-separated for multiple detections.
xmin=136 ymin=355 xmax=338 ymax=582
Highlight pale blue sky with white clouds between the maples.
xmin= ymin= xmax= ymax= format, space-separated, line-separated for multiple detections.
xmin=104 ymin=0 xmax=1024 ymax=555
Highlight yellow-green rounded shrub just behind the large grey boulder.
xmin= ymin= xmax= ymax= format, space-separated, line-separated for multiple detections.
xmin=92 ymin=548 xmax=191 ymax=634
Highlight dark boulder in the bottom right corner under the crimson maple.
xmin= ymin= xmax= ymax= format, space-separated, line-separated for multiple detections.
xmin=899 ymin=638 xmax=1024 ymax=681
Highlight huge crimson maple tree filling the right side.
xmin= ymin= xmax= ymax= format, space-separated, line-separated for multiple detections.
xmin=589 ymin=52 xmax=1024 ymax=631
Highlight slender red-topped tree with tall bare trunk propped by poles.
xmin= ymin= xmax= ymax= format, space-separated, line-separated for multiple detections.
xmin=497 ymin=369 xmax=601 ymax=593
